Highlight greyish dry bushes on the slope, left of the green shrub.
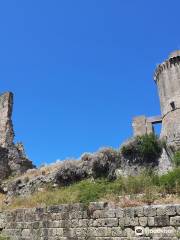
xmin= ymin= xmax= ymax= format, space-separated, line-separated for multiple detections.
xmin=52 ymin=148 xmax=120 ymax=186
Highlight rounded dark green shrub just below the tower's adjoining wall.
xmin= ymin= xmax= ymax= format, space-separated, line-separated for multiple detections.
xmin=121 ymin=134 xmax=162 ymax=163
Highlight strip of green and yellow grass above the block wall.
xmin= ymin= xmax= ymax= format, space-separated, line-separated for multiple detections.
xmin=1 ymin=168 xmax=180 ymax=209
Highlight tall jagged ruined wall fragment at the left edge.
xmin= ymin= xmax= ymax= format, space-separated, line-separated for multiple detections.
xmin=0 ymin=92 xmax=34 ymax=180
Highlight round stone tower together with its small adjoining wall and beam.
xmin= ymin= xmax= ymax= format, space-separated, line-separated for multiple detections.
xmin=132 ymin=50 xmax=180 ymax=150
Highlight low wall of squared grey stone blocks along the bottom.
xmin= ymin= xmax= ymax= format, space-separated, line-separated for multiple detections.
xmin=0 ymin=202 xmax=180 ymax=240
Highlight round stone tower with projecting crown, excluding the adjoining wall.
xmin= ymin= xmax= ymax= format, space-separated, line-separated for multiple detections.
xmin=154 ymin=50 xmax=180 ymax=149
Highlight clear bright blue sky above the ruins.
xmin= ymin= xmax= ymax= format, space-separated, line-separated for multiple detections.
xmin=0 ymin=0 xmax=180 ymax=165
